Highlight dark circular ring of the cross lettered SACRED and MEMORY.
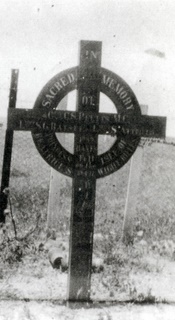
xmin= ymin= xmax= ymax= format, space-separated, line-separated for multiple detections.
xmin=32 ymin=67 xmax=141 ymax=178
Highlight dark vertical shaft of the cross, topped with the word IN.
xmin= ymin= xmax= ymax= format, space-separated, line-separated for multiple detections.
xmin=68 ymin=41 xmax=101 ymax=301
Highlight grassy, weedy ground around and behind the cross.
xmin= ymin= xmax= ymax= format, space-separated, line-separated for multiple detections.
xmin=0 ymin=131 xmax=175 ymax=319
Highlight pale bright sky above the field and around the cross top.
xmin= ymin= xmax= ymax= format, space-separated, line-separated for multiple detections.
xmin=0 ymin=0 xmax=175 ymax=136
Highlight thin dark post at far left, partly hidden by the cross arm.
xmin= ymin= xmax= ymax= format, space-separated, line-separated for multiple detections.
xmin=0 ymin=69 xmax=19 ymax=223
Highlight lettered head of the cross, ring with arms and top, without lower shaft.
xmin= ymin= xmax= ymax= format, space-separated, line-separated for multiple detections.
xmin=8 ymin=42 xmax=166 ymax=179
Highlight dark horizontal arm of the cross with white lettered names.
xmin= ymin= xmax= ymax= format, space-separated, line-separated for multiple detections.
xmin=8 ymin=109 xmax=166 ymax=138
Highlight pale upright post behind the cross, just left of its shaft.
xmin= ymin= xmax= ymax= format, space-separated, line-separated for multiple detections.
xmin=47 ymin=95 xmax=68 ymax=235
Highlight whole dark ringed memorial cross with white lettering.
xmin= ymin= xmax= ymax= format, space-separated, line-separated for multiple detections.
xmin=0 ymin=41 xmax=166 ymax=301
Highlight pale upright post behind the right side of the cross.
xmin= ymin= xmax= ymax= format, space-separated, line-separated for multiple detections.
xmin=122 ymin=105 xmax=148 ymax=245
